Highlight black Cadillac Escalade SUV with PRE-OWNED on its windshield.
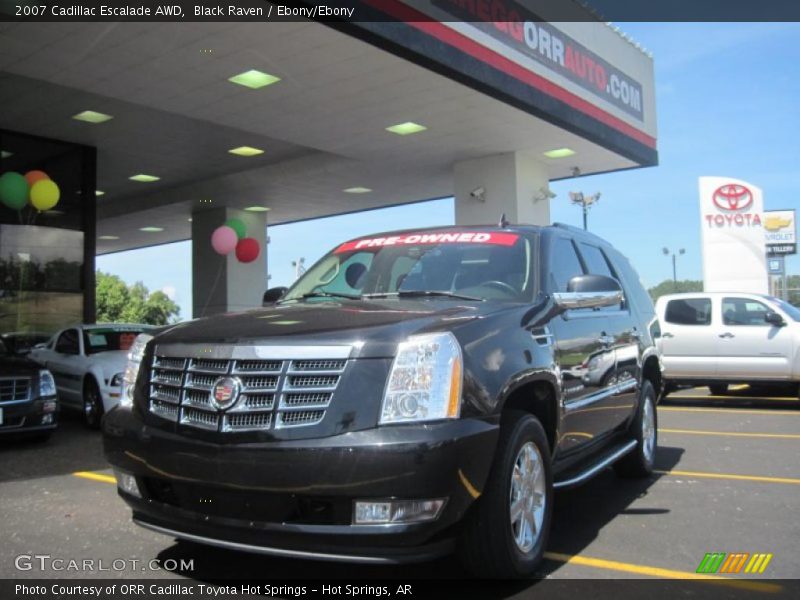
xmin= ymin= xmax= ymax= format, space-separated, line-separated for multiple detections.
xmin=103 ymin=225 xmax=662 ymax=577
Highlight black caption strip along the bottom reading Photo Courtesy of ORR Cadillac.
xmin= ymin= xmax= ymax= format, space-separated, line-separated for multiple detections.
xmin=0 ymin=578 xmax=800 ymax=600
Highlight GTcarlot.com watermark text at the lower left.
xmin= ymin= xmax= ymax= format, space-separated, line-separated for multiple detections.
xmin=14 ymin=554 xmax=194 ymax=573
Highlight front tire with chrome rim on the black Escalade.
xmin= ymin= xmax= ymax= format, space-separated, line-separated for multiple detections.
xmin=459 ymin=411 xmax=553 ymax=579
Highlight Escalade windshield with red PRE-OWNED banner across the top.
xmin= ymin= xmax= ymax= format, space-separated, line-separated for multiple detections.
xmin=283 ymin=231 xmax=533 ymax=302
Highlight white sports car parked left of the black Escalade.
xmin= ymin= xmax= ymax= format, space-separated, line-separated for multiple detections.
xmin=30 ymin=323 xmax=153 ymax=428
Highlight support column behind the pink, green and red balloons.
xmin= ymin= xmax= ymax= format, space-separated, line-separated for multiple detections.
xmin=192 ymin=208 xmax=267 ymax=318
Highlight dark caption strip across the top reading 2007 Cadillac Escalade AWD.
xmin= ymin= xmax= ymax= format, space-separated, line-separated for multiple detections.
xmin=0 ymin=0 xmax=800 ymax=22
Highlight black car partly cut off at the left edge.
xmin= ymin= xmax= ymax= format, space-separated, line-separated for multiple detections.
xmin=0 ymin=340 xmax=58 ymax=440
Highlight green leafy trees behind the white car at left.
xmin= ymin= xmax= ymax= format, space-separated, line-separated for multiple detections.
xmin=96 ymin=271 xmax=180 ymax=325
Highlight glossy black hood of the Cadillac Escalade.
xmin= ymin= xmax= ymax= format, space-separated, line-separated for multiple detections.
xmin=151 ymin=299 xmax=515 ymax=358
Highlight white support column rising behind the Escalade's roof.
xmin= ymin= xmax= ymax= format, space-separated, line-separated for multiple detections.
xmin=454 ymin=152 xmax=550 ymax=225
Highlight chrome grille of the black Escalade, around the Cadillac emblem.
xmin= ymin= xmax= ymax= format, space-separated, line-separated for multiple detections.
xmin=149 ymin=346 xmax=350 ymax=433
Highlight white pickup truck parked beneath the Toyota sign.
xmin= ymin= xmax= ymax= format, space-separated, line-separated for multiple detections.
xmin=656 ymin=292 xmax=800 ymax=394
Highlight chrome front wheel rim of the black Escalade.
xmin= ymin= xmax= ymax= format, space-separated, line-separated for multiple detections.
xmin=509 ymin=442 xmax=547 ymax=552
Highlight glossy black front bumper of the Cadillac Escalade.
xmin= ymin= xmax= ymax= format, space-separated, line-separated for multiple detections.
xmin=103 ymin=408 xmax=499 ymax=562
